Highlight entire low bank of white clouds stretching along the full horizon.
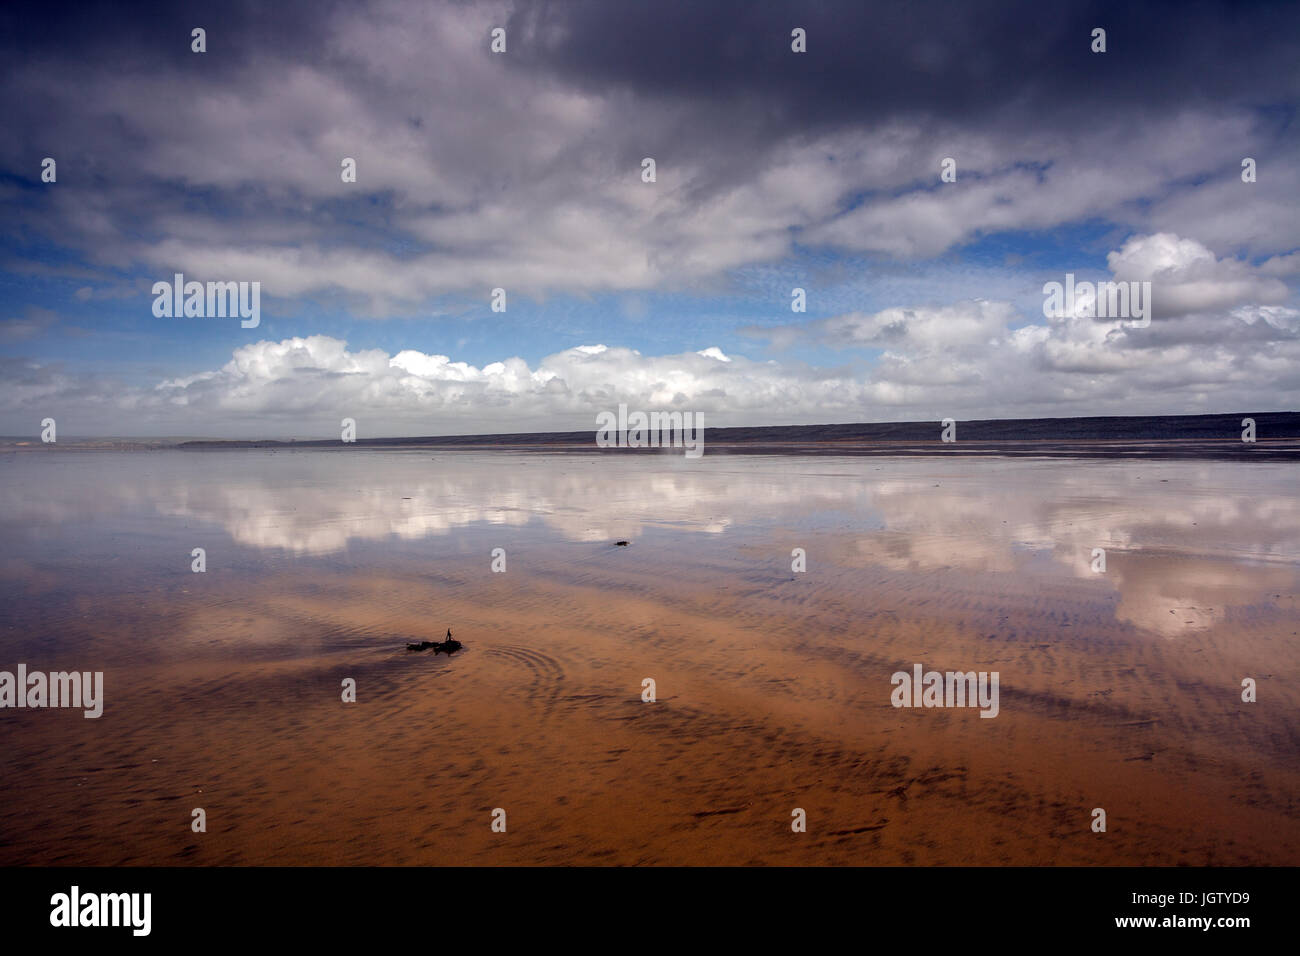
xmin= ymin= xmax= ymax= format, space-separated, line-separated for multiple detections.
xmin=0 ymin=254 xmax=1300 ymax=437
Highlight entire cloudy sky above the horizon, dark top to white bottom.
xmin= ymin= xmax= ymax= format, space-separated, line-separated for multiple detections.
xmin=0 ymin=0 xmax=1300 ymax=438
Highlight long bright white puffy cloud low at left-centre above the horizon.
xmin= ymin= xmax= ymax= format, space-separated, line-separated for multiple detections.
xmin=144 ymin=336 xmax=883 ymax=437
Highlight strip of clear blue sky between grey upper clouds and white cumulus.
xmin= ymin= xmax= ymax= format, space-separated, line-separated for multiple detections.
xmin=0 ymin=226 xmax=1106 ymax=386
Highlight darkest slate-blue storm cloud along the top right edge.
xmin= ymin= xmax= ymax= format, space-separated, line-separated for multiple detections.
xmin=511 ymin=0 xmax=1300 ymax=130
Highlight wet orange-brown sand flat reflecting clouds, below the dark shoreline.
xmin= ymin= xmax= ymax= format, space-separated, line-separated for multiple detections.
xmin=0 ymin=450 xmax=1300 ymax=865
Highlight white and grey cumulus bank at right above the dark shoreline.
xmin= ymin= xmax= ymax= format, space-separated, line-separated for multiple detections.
xmin=744 ymin=234 xmax=1300 ymax=418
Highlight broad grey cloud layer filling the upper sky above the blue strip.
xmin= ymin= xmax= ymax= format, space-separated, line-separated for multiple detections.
xmin=0 ymin=3 xmax=1300 ymax=317
